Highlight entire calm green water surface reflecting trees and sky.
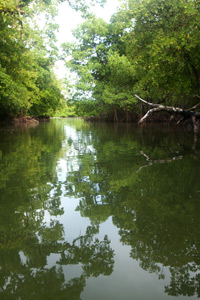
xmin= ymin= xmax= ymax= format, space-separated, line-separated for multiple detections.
xmin=0 ymin=119 xmax=200 ymax=300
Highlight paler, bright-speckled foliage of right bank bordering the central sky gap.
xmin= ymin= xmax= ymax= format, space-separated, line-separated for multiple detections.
xmin=63 ymin=17 xmax=109 ymax=115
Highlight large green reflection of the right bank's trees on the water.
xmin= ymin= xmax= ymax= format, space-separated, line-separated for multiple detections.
xmin=63 ymin=124 xmax=200 ymax=297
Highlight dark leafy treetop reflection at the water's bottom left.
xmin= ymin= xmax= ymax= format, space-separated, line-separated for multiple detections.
xmin=0 ymin=224 xmax=114 ymax=299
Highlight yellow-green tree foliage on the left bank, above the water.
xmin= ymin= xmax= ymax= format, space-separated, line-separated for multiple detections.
xmin=0 ymin=0 xmax=61 ymax=116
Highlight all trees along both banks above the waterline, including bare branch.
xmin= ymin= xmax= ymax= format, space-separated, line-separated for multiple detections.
xmin=0 ymin=0 xmax=200 ymax=131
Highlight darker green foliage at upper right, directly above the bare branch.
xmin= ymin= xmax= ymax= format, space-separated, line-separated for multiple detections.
xmin=124 ymin=0 xmax=200 ymax=106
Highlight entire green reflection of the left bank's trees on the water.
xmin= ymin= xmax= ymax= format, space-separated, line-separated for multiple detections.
xmin=0 ymin=122 xmax=114 ymax=300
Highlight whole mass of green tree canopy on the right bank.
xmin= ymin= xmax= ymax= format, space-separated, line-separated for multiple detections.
xmin=64 ymin=0 xmax=200 ymax=118
